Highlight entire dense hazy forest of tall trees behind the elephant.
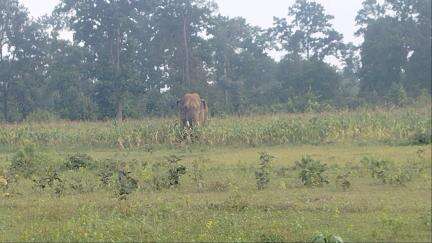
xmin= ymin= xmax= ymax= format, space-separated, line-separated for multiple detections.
xmin=0 ymin=0 xmax=431 ymax=122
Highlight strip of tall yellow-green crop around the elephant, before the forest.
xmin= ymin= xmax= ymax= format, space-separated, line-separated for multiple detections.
xmin=0 ymin=105 xmax=431 ymax=148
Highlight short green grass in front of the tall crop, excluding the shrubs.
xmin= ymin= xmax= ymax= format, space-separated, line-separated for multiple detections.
xmin=0 ymin=145 xmax=431 ymax=242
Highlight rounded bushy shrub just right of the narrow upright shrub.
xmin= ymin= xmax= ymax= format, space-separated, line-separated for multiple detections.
xmin=295 ymin=156 xmax=329 ymax=186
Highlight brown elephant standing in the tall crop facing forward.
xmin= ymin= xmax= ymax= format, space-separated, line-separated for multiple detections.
xmin=177 ymin=93 xmax=208 ymax=127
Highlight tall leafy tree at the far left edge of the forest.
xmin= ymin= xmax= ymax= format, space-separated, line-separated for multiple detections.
xmin=0 ymin=0 xmax=47 ymax=121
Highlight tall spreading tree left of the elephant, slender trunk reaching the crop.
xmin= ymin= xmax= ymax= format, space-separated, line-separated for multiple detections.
xmin=56 ymin=0 xmax=154 ymax=122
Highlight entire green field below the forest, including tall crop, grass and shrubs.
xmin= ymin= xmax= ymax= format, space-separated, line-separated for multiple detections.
xmin=0 ymin=104 xmax=432 ymax=242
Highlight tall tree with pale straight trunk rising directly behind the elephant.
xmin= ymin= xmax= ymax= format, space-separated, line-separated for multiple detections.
xmin=152 ymin=0 xmax=215 ymax=96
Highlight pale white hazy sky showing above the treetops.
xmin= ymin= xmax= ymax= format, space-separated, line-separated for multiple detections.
xmin=20 ymin=0 xmax=362 ymax=42
